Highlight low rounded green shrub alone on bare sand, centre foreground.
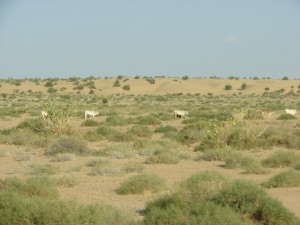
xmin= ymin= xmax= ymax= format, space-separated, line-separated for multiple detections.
xmin=117 ymin=174 xmax=166 ymax=195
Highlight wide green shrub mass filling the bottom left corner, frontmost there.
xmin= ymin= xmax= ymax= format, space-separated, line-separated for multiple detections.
xmin=0 ymin=191 xmax=132 ymax=225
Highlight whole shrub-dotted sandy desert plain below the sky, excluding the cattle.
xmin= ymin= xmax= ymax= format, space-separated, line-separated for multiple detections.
xmin=0 ymin=75 xmax=300 ymax=225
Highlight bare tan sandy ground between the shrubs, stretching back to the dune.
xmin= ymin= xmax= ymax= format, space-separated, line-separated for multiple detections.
xmin=0 ymin=77 xmax=300 ymax=223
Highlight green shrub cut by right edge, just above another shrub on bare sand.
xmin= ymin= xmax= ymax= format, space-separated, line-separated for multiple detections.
xmin=262 ymin=151 xmax=300 ymax=168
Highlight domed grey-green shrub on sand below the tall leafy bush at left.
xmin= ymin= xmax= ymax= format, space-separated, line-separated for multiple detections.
xmin=46 ymin=136 xmax=90 ymax=155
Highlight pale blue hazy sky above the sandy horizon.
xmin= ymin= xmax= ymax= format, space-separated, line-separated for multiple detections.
xmin=0 ymin=0 xmax=300 ymax=79
